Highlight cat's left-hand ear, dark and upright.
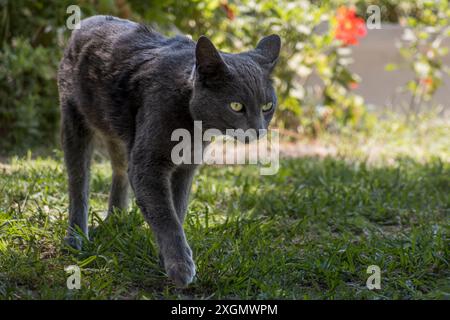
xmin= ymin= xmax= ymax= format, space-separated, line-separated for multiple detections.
xmin=195 ymin=36 xmax=228 ymax=81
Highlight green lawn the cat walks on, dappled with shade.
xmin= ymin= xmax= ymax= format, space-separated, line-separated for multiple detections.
xmin=0 ymin=117 xmax=450 ymax=299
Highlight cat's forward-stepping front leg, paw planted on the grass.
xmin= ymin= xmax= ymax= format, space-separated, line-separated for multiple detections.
xmin=129 ymin=154 xmax=195 ymax=287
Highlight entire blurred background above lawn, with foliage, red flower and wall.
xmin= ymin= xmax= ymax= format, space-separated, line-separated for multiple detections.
xmin=0 ymin=0 xmax=450 ymax=156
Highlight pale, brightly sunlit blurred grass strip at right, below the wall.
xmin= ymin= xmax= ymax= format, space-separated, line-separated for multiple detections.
xmin=322 ymin=113 xmax=450 ymax=163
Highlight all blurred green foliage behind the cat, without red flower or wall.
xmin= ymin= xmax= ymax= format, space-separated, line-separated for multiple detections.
xmin=0 ymin=0 xmax=449 ymax=153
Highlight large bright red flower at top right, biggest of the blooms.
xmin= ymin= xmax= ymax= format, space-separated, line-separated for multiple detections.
xmin=335 ymin=7 xmax=367 ymax=45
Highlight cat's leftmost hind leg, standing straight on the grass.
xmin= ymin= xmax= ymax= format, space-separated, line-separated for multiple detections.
xmin=61 ymin=101 xmax=93 ymax=249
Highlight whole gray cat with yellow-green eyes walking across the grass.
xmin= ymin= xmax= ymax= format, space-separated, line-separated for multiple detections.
xmin=58 ymin=16 xmax=280 ymax=287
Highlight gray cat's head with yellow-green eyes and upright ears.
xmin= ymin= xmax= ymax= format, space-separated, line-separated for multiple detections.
xmin=190 ymin=35 xmax=281 ymax=141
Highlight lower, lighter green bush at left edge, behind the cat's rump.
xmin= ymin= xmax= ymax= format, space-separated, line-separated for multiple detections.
xmin=0 ymin=38 xmax=59 ymax=151
